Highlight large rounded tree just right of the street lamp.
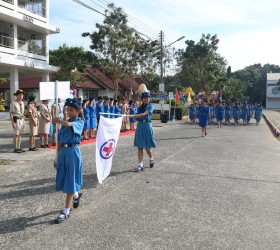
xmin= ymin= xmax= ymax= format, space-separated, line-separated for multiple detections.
xmin=177 ymin=34 xmax=226 ymax=92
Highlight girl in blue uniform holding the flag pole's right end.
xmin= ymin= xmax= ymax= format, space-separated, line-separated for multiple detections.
xmin=130 ymin=92 xmax=156 ymax=172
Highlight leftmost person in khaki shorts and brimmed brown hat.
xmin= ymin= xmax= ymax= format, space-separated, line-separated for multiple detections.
xmin=10 ymin=89 xmax=25 ymax=153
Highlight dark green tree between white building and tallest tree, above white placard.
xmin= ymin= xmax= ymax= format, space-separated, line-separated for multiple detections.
xmin=50 ymin=44 xmax=96 ymax=88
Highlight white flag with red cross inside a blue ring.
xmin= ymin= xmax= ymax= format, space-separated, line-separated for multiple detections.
xmin=96 ymin=116 xmax=122 ymax=184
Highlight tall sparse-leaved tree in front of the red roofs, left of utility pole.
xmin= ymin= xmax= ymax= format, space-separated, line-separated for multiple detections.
xmin=82 ymin=4 xmax=157 ymax=97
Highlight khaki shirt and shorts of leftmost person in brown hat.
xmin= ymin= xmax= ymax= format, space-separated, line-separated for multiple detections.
xmin=10 ymin=101 xmax=25 ymax=135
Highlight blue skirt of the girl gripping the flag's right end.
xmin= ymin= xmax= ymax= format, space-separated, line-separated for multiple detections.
xmin=134 ymin=122 xmax=156 ymax=148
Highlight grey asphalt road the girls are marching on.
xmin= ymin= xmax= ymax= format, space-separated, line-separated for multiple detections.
xmin=0 ymin=121 xmax=280 ymax=249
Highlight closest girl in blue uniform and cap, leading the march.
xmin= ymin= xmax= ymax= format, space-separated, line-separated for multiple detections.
xmin=54 ymin=99 xmax=84 ymax=223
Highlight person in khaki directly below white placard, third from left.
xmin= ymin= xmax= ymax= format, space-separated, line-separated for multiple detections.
xmin=39 ymin=100 xmax=51 ymax=148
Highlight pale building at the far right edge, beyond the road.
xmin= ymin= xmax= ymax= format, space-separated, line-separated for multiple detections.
xmin=266 ymin=73 xmax=280 ymax=109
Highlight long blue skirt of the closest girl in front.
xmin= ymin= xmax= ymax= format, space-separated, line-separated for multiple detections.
xmin=56 ymin=146 xmax=83 ymax=194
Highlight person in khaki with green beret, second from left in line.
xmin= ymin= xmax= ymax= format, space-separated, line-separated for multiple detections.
xmin=27 ymin=95 xmax=39 ymax=151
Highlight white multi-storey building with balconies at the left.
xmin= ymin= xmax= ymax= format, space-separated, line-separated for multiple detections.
xmin=0 ymin=0 xmax=59 ymax=103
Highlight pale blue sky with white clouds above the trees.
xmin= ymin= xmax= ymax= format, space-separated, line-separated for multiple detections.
xmin=49 ymin=0 xmax=280 ymax=71
